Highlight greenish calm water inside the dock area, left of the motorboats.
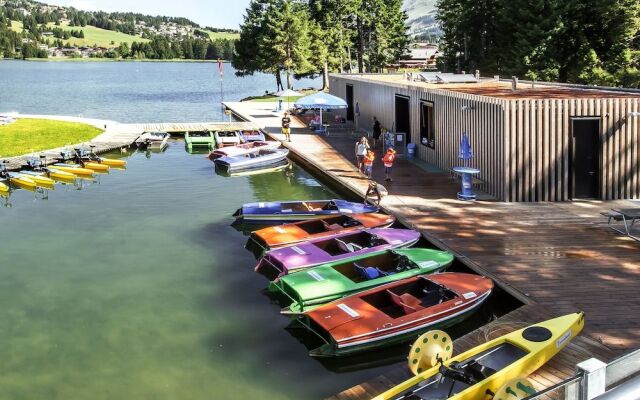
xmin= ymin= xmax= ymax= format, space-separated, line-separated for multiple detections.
xmin=0 ymin=142 xmax=400 ymax=400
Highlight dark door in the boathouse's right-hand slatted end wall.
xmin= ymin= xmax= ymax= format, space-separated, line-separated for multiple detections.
xmin=571 ymin=118 xmax=600 ymax=199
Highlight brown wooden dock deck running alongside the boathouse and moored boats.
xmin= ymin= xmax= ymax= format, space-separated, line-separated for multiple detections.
xmin=226 ymin=103 xmax=640 ymax=399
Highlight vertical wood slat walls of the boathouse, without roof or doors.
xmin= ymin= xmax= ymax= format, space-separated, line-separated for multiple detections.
xmin=331 ymin=75 xmax=640 ymax=202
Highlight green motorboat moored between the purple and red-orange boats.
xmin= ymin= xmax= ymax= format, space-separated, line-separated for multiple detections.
xmin=269 ymin=248 xmax=453 ymax=315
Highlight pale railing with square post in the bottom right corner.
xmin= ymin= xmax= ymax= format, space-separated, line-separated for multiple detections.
xmin=524 ymin=349 xmax=640 ymax=400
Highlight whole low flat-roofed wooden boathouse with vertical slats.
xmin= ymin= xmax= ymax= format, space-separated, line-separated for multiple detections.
xmin=330 ymin=73 xmax=640 ymax=202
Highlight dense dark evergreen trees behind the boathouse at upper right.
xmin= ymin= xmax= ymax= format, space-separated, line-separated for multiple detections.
xmin=437 ymin=0 xmax=640 ymax=87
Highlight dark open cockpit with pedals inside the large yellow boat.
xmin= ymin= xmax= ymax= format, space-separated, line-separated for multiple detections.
xmin=395 ymin=342 xmax=528 ymax=400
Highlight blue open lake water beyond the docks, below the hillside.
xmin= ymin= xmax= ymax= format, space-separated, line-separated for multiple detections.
xmin=0 ymin=61 xmax=322 ymax=122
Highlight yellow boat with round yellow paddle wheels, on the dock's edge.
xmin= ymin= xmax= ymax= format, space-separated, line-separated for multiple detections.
xmin=374 ymin=313 xmax=584 ymax=400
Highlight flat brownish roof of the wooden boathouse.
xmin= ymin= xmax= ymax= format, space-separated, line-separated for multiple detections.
xmin=336 ymin=73 xmax=640 ymax=100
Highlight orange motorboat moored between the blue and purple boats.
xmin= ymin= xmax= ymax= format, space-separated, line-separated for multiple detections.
xmin=246 ymin=213 xmax=396 ymax=253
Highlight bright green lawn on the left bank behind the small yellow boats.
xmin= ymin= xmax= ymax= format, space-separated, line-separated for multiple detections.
xmin=0 ymin=119 xmax=102 ymax=157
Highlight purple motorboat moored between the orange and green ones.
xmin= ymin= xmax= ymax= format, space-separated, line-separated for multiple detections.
xmin=255 ymin=228 xmax=420 ymax=281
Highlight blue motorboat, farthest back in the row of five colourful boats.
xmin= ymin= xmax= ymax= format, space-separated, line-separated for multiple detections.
xmin=233 ymin=199 xmax=378 ymax=223
